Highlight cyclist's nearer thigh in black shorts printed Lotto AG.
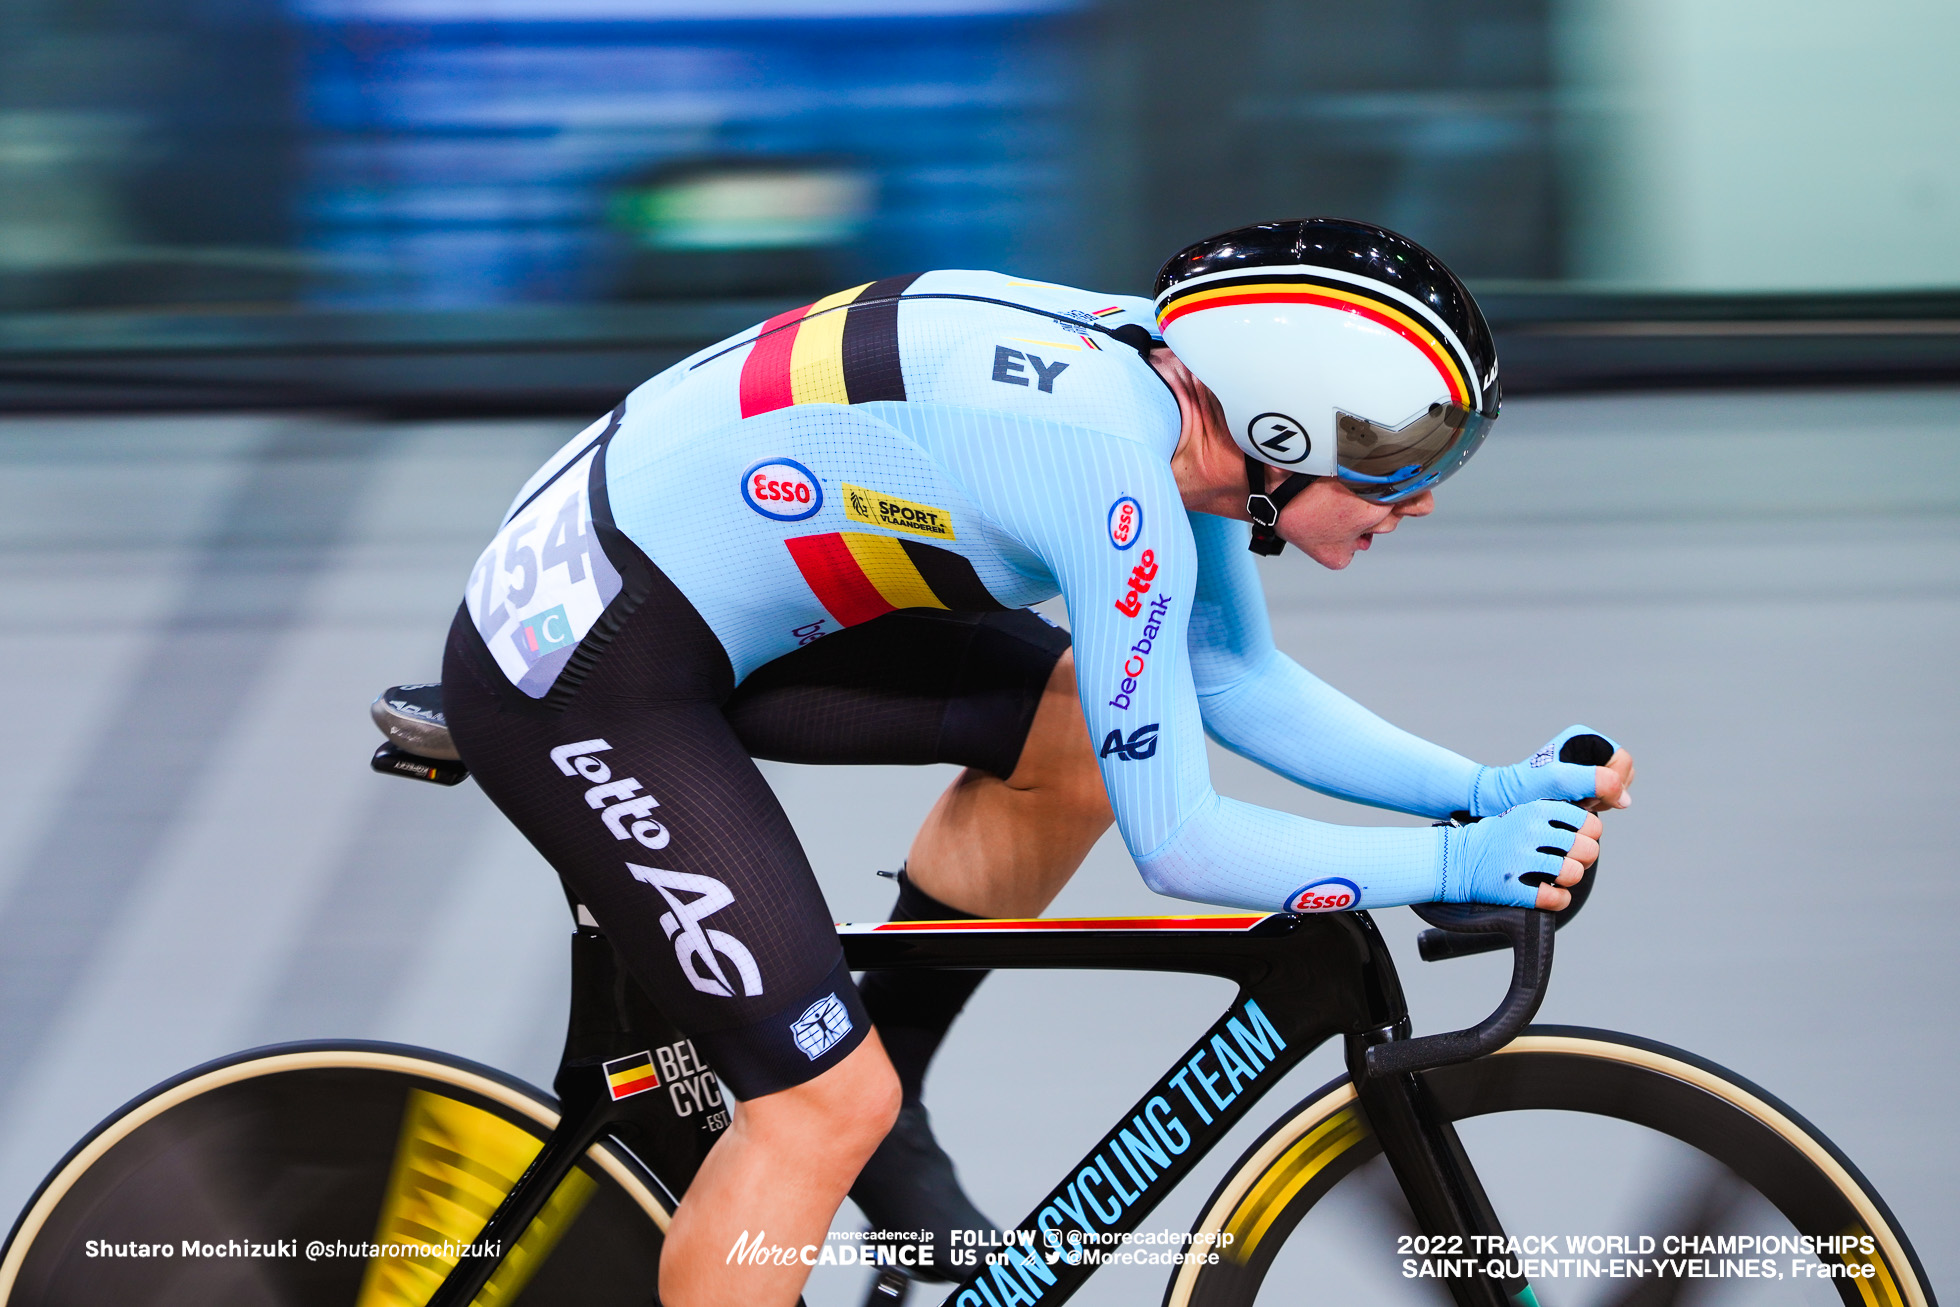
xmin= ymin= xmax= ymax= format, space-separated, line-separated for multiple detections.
xmin=443 ymin=600 xmax=870 ymax=1097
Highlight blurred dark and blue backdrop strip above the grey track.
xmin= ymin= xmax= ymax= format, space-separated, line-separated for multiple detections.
xmin=11 ymin=0 xmax=1960 ymax=403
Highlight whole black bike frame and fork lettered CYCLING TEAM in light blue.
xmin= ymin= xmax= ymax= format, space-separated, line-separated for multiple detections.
xmin=429 ymin=913 xmax=1548 ymax=1307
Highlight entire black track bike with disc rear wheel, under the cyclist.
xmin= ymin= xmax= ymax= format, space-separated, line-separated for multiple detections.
xmin=0 ymin=688 xmax=1936 ymax=1307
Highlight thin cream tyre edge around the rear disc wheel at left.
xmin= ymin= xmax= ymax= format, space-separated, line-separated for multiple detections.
xmin=0 ymin=1048 xmax=668 ymax=1303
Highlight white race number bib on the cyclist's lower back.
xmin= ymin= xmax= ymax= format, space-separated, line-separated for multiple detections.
xmin=465 ymin=449 xmax=619 ymax=700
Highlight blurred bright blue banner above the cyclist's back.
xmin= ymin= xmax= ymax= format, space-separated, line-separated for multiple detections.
xmin=294 ymin=0 xmax=1084 ymax=308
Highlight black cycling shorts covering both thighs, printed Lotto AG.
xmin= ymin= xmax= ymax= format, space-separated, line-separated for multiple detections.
xmin=443 ymin=558 xmax=1068 ymax=1099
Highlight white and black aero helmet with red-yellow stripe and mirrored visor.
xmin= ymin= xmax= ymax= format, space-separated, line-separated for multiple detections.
xmin=1156 ymin=218 xmax=1499 ymax=553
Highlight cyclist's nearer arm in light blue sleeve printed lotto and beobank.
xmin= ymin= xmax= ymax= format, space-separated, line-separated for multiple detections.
xmin=913 ymin=415 xmax=1572 ymax=911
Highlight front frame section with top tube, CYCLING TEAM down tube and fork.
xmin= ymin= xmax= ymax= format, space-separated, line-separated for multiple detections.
xmin=843 ymin=913 xmax=1529 ymax=1307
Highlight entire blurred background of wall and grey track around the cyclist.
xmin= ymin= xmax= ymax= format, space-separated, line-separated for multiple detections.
xmin=0 ymin=0 xmax=1960 ymax=1307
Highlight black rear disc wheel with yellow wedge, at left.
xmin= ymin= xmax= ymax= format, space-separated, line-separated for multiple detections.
xmin=0 ymin=1042 xmax=670 ymax=1307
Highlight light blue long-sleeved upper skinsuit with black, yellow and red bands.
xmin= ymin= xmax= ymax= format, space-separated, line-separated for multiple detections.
xmin=468 ymin=272 xmax=1593 ymax=911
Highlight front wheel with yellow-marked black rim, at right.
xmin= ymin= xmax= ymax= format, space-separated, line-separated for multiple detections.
xmin=1164 ymin=1027 xmax=1936 ymax=1307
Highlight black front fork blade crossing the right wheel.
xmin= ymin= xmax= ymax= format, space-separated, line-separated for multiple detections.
xmin=1347 ymin=1031 xmax=1537 ymax=1307
